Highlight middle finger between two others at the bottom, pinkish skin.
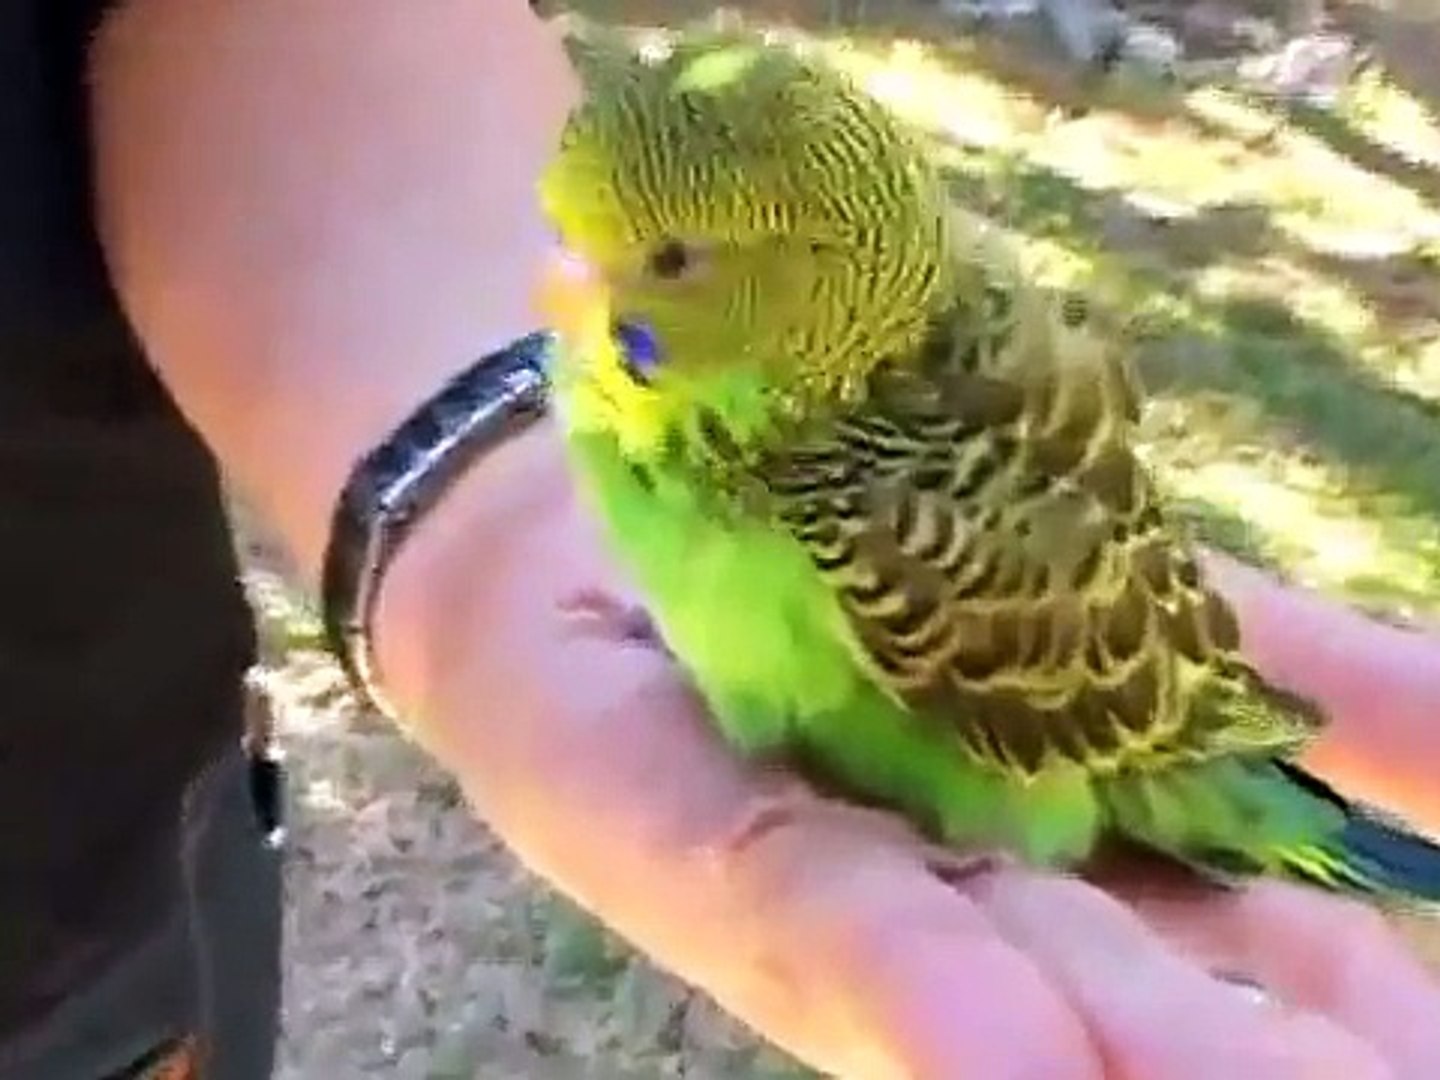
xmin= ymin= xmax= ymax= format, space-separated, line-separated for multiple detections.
xmin=981 ymin=871 xmax=1390 ymax=1080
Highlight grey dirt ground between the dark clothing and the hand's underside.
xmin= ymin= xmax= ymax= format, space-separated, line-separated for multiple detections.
xmin=236 ymin=521 xmax=806 ymax=1080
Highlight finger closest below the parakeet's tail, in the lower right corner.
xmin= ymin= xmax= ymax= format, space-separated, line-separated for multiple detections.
xmin=1132 ymin=881 xmax=1440 ymax=1077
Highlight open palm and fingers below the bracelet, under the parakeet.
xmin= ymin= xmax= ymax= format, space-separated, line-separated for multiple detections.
xmin=380 ymin=435 xmax=1440 ymax=1080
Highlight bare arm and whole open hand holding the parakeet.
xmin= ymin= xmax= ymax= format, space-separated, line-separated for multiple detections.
xmin=92 ymin=0 xmax=1440 ymax=1080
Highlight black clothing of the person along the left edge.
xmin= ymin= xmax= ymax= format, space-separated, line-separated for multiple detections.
xmin=0 ymin=0 xmax=253 ymax=1043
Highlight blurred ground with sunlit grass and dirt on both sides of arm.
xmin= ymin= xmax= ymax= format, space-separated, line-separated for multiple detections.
xmin=245 ymin=0 xmax=1440 ymax=1080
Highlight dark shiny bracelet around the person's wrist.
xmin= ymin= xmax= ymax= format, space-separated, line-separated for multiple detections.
xmin=321 ymin=333 xmax=552 ymax=717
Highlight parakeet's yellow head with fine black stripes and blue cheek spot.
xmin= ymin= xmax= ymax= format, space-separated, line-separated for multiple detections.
xmin=540 ymin=35 xmax=945 ymax=452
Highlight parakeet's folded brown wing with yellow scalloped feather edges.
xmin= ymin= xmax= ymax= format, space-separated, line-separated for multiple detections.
xmin=763 ymin=276 xmax=1318 ymax=775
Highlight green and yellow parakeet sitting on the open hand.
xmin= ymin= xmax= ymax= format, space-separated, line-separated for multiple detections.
xmin=541 ymin=33 xmax=1440 ymax=901
